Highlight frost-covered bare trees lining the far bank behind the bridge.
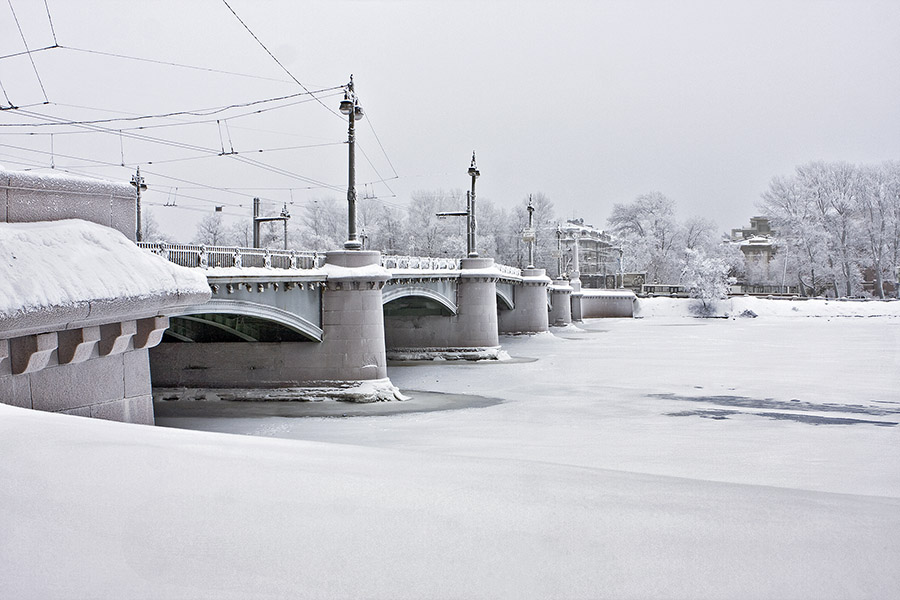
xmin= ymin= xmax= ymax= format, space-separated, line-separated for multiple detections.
xmin=178 ymin=162 xmax=900 ymax=297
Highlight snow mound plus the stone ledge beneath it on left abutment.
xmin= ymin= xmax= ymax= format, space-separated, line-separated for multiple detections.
xmin=0 ymin=219 xmax=209 ymax=336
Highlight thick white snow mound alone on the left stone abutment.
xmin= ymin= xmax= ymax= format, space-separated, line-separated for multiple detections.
xmin=0 ymin=219 xmax=209 ymax=319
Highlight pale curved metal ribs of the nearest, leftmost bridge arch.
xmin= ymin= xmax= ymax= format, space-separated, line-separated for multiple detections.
xmin=166 ymin=298 xmax=323 ymax=342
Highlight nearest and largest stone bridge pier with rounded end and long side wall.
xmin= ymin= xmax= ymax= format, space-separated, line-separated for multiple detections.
xmin=150 ymin=251 xmax=396 ymax=402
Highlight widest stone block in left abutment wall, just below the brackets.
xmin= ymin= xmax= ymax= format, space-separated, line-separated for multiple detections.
xmin=31 ymin=356 xmax=125 ymax=412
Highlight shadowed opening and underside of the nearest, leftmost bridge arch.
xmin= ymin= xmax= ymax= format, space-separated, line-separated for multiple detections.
xmin=165 ymin=299 xmax=323 ymax=343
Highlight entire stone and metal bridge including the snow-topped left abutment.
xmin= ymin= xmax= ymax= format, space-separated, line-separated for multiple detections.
xmin=0 ymin=170 xmax=631 ymax=423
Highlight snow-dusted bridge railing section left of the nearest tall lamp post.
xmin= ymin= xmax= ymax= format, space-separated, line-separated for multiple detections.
xmin=137 ymin=242 xmax=325 ymax=269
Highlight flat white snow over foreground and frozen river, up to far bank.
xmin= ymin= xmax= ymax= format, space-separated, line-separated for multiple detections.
xmin=0 ymin=298 xmax=900 ymax=599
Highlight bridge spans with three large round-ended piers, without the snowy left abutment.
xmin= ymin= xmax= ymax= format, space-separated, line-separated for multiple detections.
xmin=139 ymin=243 xmax=551 ymax=389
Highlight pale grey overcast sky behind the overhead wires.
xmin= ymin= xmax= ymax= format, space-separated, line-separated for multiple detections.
xmin=0 ymin=0 xmax=900 ymax=239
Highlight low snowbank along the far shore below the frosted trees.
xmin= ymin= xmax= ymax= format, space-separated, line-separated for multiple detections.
xmin=635 ymin=296 xmax=900 ymax=317
